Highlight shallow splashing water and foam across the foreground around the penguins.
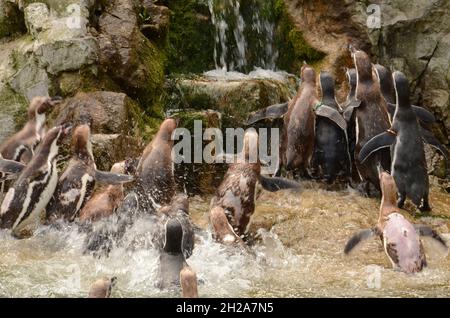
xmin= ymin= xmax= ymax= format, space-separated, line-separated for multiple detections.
xmin=0 ymin=183 xmax=450 ymax=297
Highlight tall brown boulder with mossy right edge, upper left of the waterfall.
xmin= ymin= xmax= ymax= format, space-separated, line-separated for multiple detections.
xmin=98 ymin=0 xmax=164 ymax=107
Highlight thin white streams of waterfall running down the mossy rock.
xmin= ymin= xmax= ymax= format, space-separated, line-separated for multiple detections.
xmin=208 ymin=0 xmax=278 ymax=73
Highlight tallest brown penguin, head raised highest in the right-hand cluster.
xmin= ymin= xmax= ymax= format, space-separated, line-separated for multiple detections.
xmin=348 ymin=47 xmax=391 ymax=192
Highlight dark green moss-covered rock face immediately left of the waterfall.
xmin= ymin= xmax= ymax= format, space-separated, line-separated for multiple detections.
xmin=167 ymin=0 xmax=214 ymax=74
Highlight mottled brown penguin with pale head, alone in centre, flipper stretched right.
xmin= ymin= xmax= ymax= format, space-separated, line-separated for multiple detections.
xmin=210 ymin=129 xmax=300 ymax=236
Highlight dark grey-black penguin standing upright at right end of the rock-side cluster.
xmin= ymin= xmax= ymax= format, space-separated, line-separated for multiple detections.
xmin=359 ymin=72 xmax=442 ymax=211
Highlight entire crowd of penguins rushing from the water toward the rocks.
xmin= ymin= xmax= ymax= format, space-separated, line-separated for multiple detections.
xmin=0 ymin=48 xmax=447 ymax=297
